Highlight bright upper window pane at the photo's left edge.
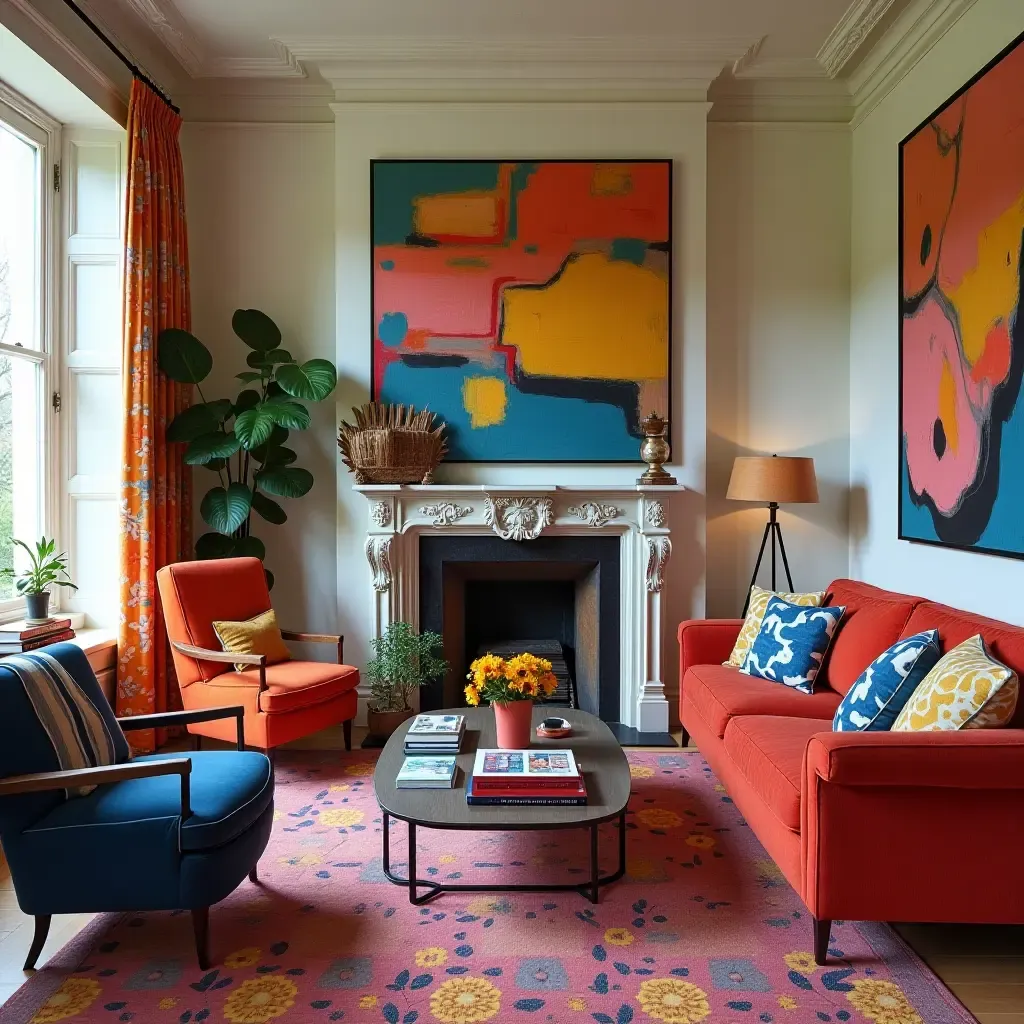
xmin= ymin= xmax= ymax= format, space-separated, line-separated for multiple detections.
xmin=0 ymin=122 xmax=39 ymax=348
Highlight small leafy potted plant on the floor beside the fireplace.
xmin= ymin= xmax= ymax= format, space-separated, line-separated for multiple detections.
xmin=367 ymin=623 xmax=447 ymax=739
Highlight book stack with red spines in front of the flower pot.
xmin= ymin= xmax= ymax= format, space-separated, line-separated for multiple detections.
xmin=466 ymin=749 xmax=587 ymax=807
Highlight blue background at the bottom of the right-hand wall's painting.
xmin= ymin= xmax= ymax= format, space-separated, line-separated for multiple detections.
xmin=900 ymin=396 xmax=1024 ymax=555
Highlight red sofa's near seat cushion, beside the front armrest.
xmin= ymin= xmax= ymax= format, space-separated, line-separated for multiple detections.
xmin=723 ymin=715 xmax=830 ymax=833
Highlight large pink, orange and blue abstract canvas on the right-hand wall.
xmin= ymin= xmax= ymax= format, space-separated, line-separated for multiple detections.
xmin=899 ymin=37 xmax=1024 ymax=557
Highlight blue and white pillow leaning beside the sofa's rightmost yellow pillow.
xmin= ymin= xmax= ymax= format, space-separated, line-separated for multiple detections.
xmin=833 ymin=630 xmax=942 ymax=732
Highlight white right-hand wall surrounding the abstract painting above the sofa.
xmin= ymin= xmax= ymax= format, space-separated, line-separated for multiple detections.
xmin=850 ymin=0 xmax=1024 ymax=624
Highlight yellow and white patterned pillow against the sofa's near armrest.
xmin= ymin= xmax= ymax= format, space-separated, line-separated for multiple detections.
xmin=892 ymin=635 xmax=1019 ymax=732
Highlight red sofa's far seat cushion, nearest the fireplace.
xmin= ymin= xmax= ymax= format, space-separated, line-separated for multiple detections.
xmin=683 ymin=665 xmax=843 ymax=738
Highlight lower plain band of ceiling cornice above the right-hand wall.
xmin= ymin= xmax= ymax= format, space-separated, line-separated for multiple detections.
xmin=849 ymin=0 xmax=975 ymax=126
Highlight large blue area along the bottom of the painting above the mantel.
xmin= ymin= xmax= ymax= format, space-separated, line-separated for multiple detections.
xmin=380 ymin=361 xmax=640 ymax=462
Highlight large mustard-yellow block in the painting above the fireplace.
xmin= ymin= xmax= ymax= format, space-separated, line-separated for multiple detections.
xmin=502 ymin=253 xmax=669 ymax=381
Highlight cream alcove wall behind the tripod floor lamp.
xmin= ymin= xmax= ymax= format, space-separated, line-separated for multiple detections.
xmin=708 ymin=122 xmax=850 ymax=617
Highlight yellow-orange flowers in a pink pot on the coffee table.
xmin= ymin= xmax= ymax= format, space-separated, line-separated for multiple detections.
xmin=466 ymin=652 xmax=558 ymax=751
